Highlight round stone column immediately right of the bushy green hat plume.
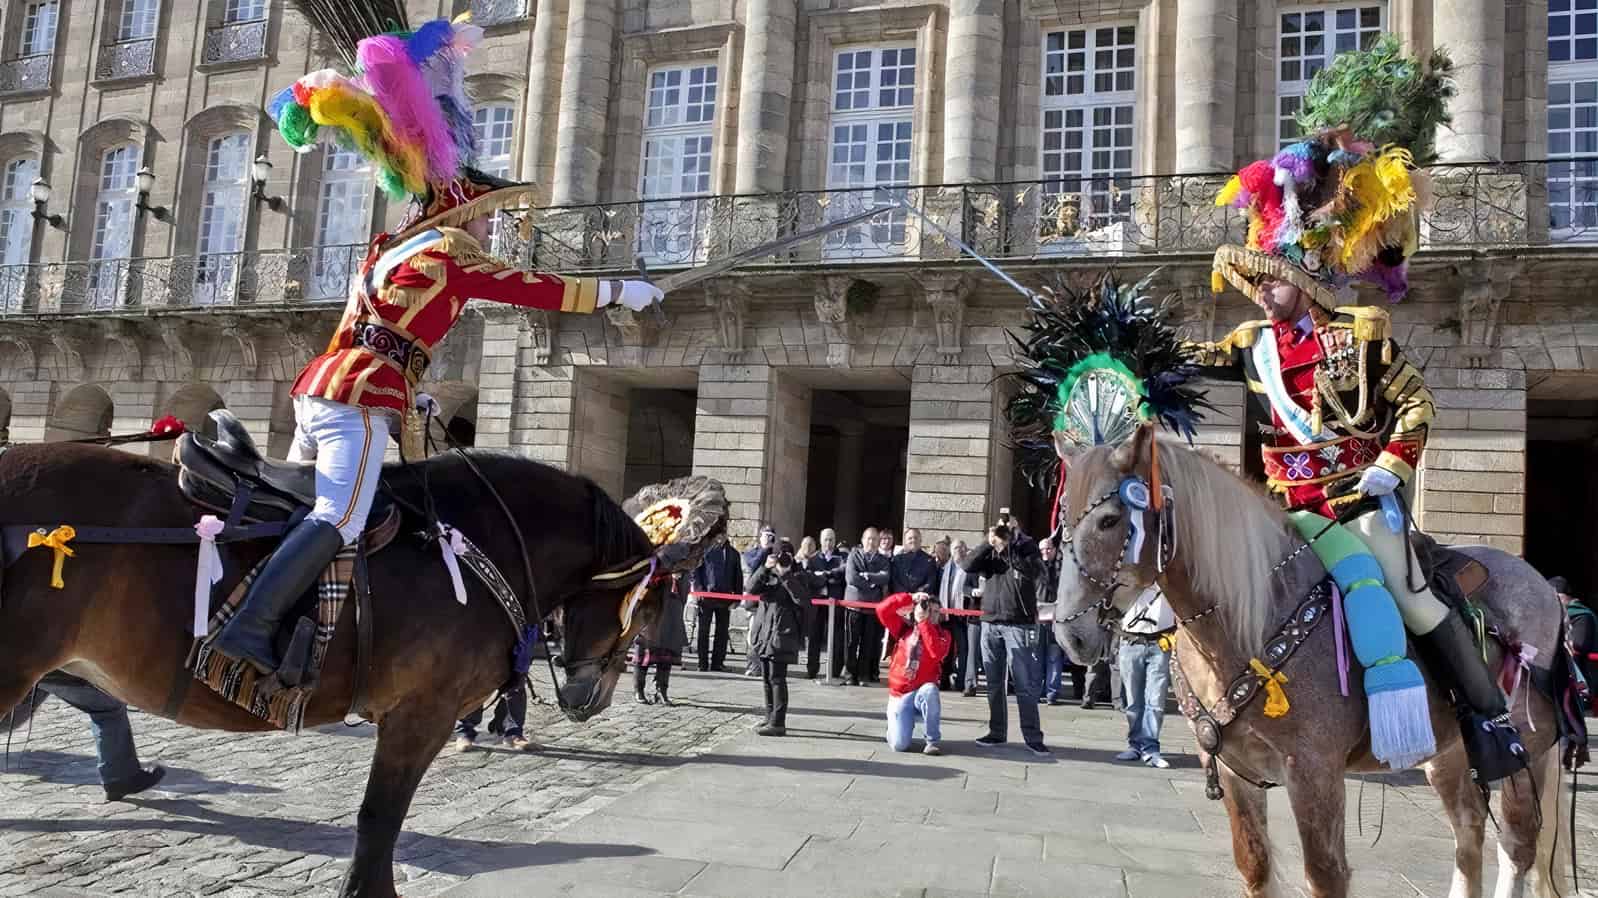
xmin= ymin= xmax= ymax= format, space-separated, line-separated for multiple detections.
xmin=1432 ymin=0 xmax=1504 ymax=161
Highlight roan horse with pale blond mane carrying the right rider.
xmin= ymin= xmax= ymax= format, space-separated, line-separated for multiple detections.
xmin=1056 ymin=427 xmax=1563 ymax=898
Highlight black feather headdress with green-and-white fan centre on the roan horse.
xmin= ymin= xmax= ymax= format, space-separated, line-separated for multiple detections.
xmin=1005 ymin=272 xmax=1211 ymax=486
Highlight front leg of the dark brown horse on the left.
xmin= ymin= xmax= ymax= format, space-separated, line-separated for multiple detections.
xmin=339 ymin=703 xmax=454 ymax=898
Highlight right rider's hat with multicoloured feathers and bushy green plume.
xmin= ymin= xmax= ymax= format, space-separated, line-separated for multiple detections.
xmin=1211 ymin=35 xmax=1454 ymax=308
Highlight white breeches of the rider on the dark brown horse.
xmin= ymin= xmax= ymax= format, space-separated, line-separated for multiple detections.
xmin=289 ymin=396 xmax=390 ymax=545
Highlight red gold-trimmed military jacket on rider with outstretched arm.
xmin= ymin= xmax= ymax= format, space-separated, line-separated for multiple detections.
xmin=291 ymin=227 xmax=599 ymax=415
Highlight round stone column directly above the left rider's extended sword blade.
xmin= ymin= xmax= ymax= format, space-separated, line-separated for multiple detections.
xmin=733 ymin=0 xmax=799 ymax=193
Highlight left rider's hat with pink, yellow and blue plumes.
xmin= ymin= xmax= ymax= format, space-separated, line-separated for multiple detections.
xmin=268 ymin=0 xmax=532 ymax=238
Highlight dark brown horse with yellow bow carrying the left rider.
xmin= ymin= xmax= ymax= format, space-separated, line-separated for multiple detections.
xmin=0 ymin=444 xmax=677 ymax=898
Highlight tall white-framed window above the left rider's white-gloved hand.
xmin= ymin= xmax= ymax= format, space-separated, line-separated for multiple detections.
xmin=638 ymin=66 xmax=718 ymax=262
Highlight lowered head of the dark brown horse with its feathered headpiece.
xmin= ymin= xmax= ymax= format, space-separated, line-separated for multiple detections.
xmin=558 ymin=478 xmax=727 ymax=721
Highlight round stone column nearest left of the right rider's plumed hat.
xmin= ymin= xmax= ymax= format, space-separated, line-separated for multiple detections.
xmin=1175 ymin=0 xmax=1238 ymax=173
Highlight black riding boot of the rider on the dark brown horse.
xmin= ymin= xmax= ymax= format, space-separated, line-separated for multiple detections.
xmin=214 ymin=519 xmax=344 ymax=674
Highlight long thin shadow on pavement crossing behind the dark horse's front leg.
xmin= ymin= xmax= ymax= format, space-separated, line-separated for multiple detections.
xmin=0 ymin=799 xmax=655 ymax=876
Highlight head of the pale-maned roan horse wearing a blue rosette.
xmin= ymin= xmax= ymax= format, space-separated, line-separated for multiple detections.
xmin=1055 ymin=423 xmax=1160 ymax=665
